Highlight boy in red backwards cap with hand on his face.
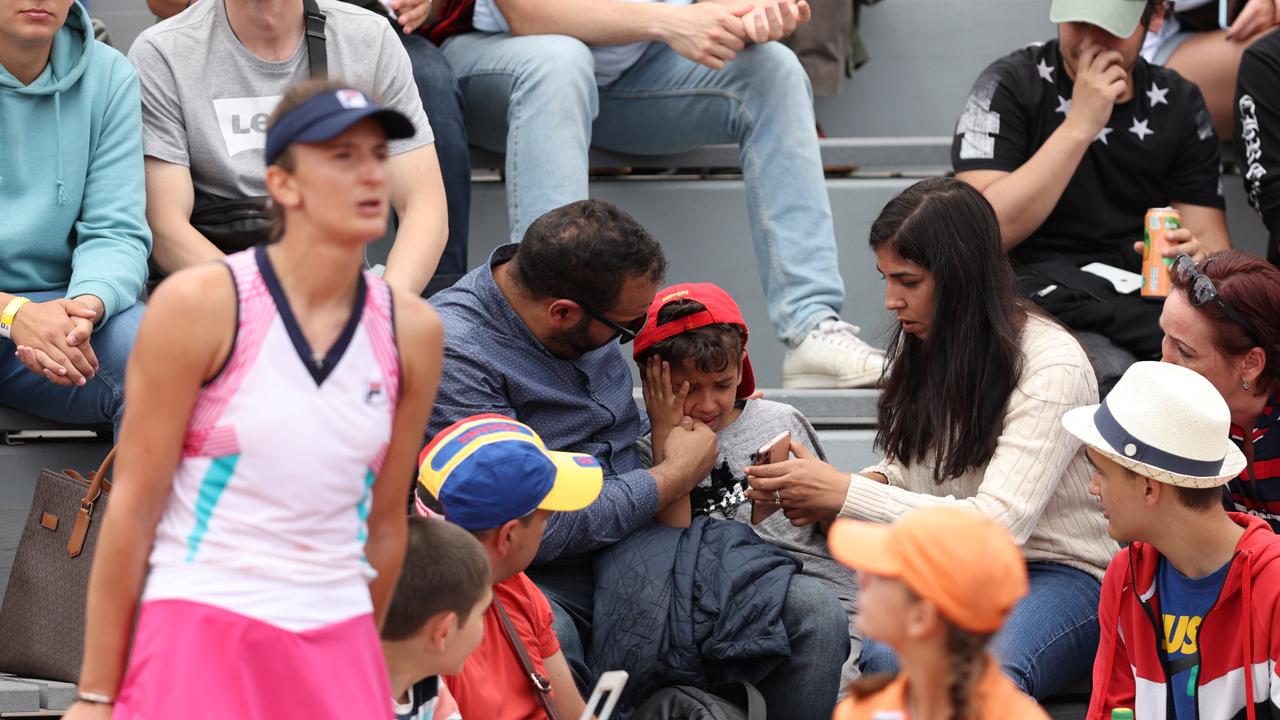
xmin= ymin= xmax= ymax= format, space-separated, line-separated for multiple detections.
xmin=634 ymin=283 xmax=861 ymax=679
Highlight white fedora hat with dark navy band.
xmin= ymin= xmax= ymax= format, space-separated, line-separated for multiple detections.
xmin=1062 ymin=363 xmax=1245 ymax=488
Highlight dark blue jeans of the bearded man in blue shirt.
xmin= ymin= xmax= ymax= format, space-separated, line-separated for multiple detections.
xmin=529 ymin=564 xmax=849 ymax=720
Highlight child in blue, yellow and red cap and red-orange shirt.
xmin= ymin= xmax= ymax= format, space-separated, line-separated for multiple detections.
xmin=419 ymin=415 xmax=604 ymax=720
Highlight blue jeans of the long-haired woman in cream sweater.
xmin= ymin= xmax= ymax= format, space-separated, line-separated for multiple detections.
xmin=861 ymin=562 xmax=1102 ymax=700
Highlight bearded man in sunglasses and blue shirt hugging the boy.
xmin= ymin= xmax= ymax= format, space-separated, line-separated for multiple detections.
xmin=424 ymin=200 xmax=849 ymax=720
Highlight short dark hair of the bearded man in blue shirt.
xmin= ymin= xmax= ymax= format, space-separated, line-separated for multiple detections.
xmin=511 ymin=200 xmax=667 ymax=311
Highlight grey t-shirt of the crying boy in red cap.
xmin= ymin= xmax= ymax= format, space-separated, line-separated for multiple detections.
xmin=637 ymin=400 xmax=858 ymax=615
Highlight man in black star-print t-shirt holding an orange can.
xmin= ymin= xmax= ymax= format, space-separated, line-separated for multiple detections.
xmin=951 ymin=0 xmax=1230 ymax=395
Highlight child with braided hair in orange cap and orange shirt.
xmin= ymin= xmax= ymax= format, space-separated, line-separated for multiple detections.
xmin=829 ymin=507 xmax=1048 ymax=720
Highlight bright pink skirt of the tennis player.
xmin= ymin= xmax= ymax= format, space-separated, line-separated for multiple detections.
xmin=113 ymin=600 xmax=394 ymax=720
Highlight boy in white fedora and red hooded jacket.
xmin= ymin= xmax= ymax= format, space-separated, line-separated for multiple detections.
xmin=1062 ymin=363 xmax=1280 ymax=720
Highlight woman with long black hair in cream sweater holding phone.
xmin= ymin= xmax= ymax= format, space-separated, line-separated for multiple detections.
xmin=748 ymin=178 xmax=1117 ymax=697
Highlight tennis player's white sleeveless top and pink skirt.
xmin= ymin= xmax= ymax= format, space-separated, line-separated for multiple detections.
xmin=114 ymin=243 xmax=401 ymax=720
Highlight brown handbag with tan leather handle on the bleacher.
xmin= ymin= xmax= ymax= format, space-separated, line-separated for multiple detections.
xmin=0 ymin=448 xmax=115 ymax=683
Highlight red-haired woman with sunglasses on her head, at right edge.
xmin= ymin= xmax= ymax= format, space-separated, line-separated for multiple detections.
xmin=1160 ymin=250 xmax=1280 ymax=530
